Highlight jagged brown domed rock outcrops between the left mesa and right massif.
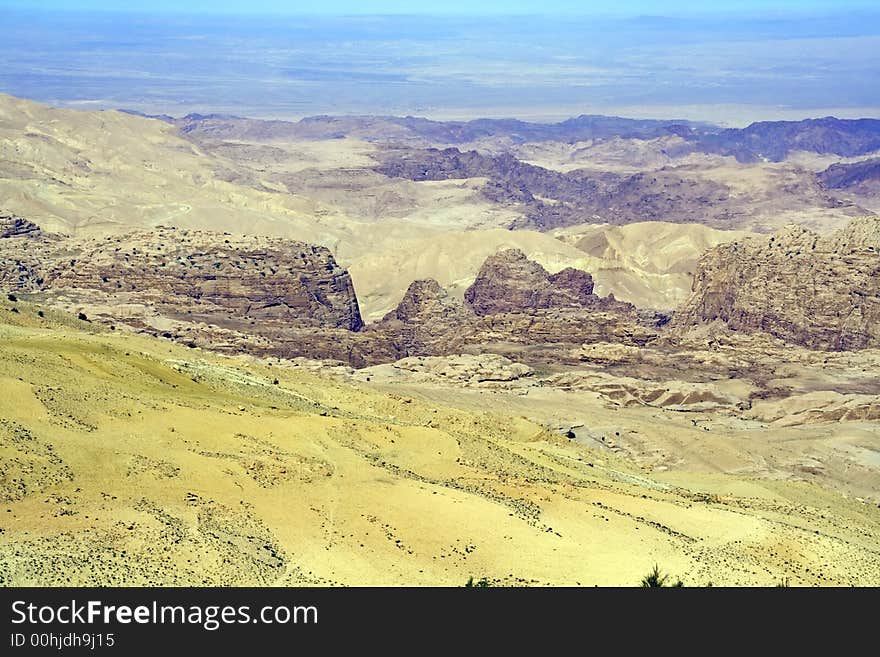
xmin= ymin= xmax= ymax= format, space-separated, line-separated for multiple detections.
xmin=368 ymin=249 xmax=657 ymax=360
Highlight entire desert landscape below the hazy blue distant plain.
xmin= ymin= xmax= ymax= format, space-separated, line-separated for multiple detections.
xmin=0 ymin=95 xmax=880 ymax=586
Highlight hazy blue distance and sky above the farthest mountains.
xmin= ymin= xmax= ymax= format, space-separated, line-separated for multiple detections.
xmin=0 ymin=0 xmax=880 ymax=125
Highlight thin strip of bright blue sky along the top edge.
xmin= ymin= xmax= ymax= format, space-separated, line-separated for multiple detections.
xmin=6 ymin=0 xmax=877 ymax=15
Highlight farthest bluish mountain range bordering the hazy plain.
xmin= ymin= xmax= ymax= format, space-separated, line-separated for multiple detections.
xmin=165 ymin=114 xmax=880 ymax=162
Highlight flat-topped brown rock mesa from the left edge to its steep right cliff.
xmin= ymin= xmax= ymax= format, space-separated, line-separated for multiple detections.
xmin=0 ymin=227 xmax=374 ymax=360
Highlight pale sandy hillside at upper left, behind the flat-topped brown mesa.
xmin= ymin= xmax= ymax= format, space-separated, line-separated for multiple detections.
xmin=0 ymin=95 xmax=345 ymax=242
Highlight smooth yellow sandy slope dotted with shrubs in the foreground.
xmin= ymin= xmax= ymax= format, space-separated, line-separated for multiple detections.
xmin=0 ymin=300 xmax=880 ymax=585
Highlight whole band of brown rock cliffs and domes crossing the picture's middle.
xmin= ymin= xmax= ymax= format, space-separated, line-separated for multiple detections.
xmin=6 ymin=217 xmax=880 ymax=367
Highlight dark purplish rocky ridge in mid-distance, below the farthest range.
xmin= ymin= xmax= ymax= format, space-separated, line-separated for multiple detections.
xmin=374 ymin=148 xmax=852 ymax=230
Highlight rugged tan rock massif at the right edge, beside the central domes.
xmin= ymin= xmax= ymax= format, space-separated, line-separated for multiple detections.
xmin=673 ymin=217 xmax=880 ymax=351
